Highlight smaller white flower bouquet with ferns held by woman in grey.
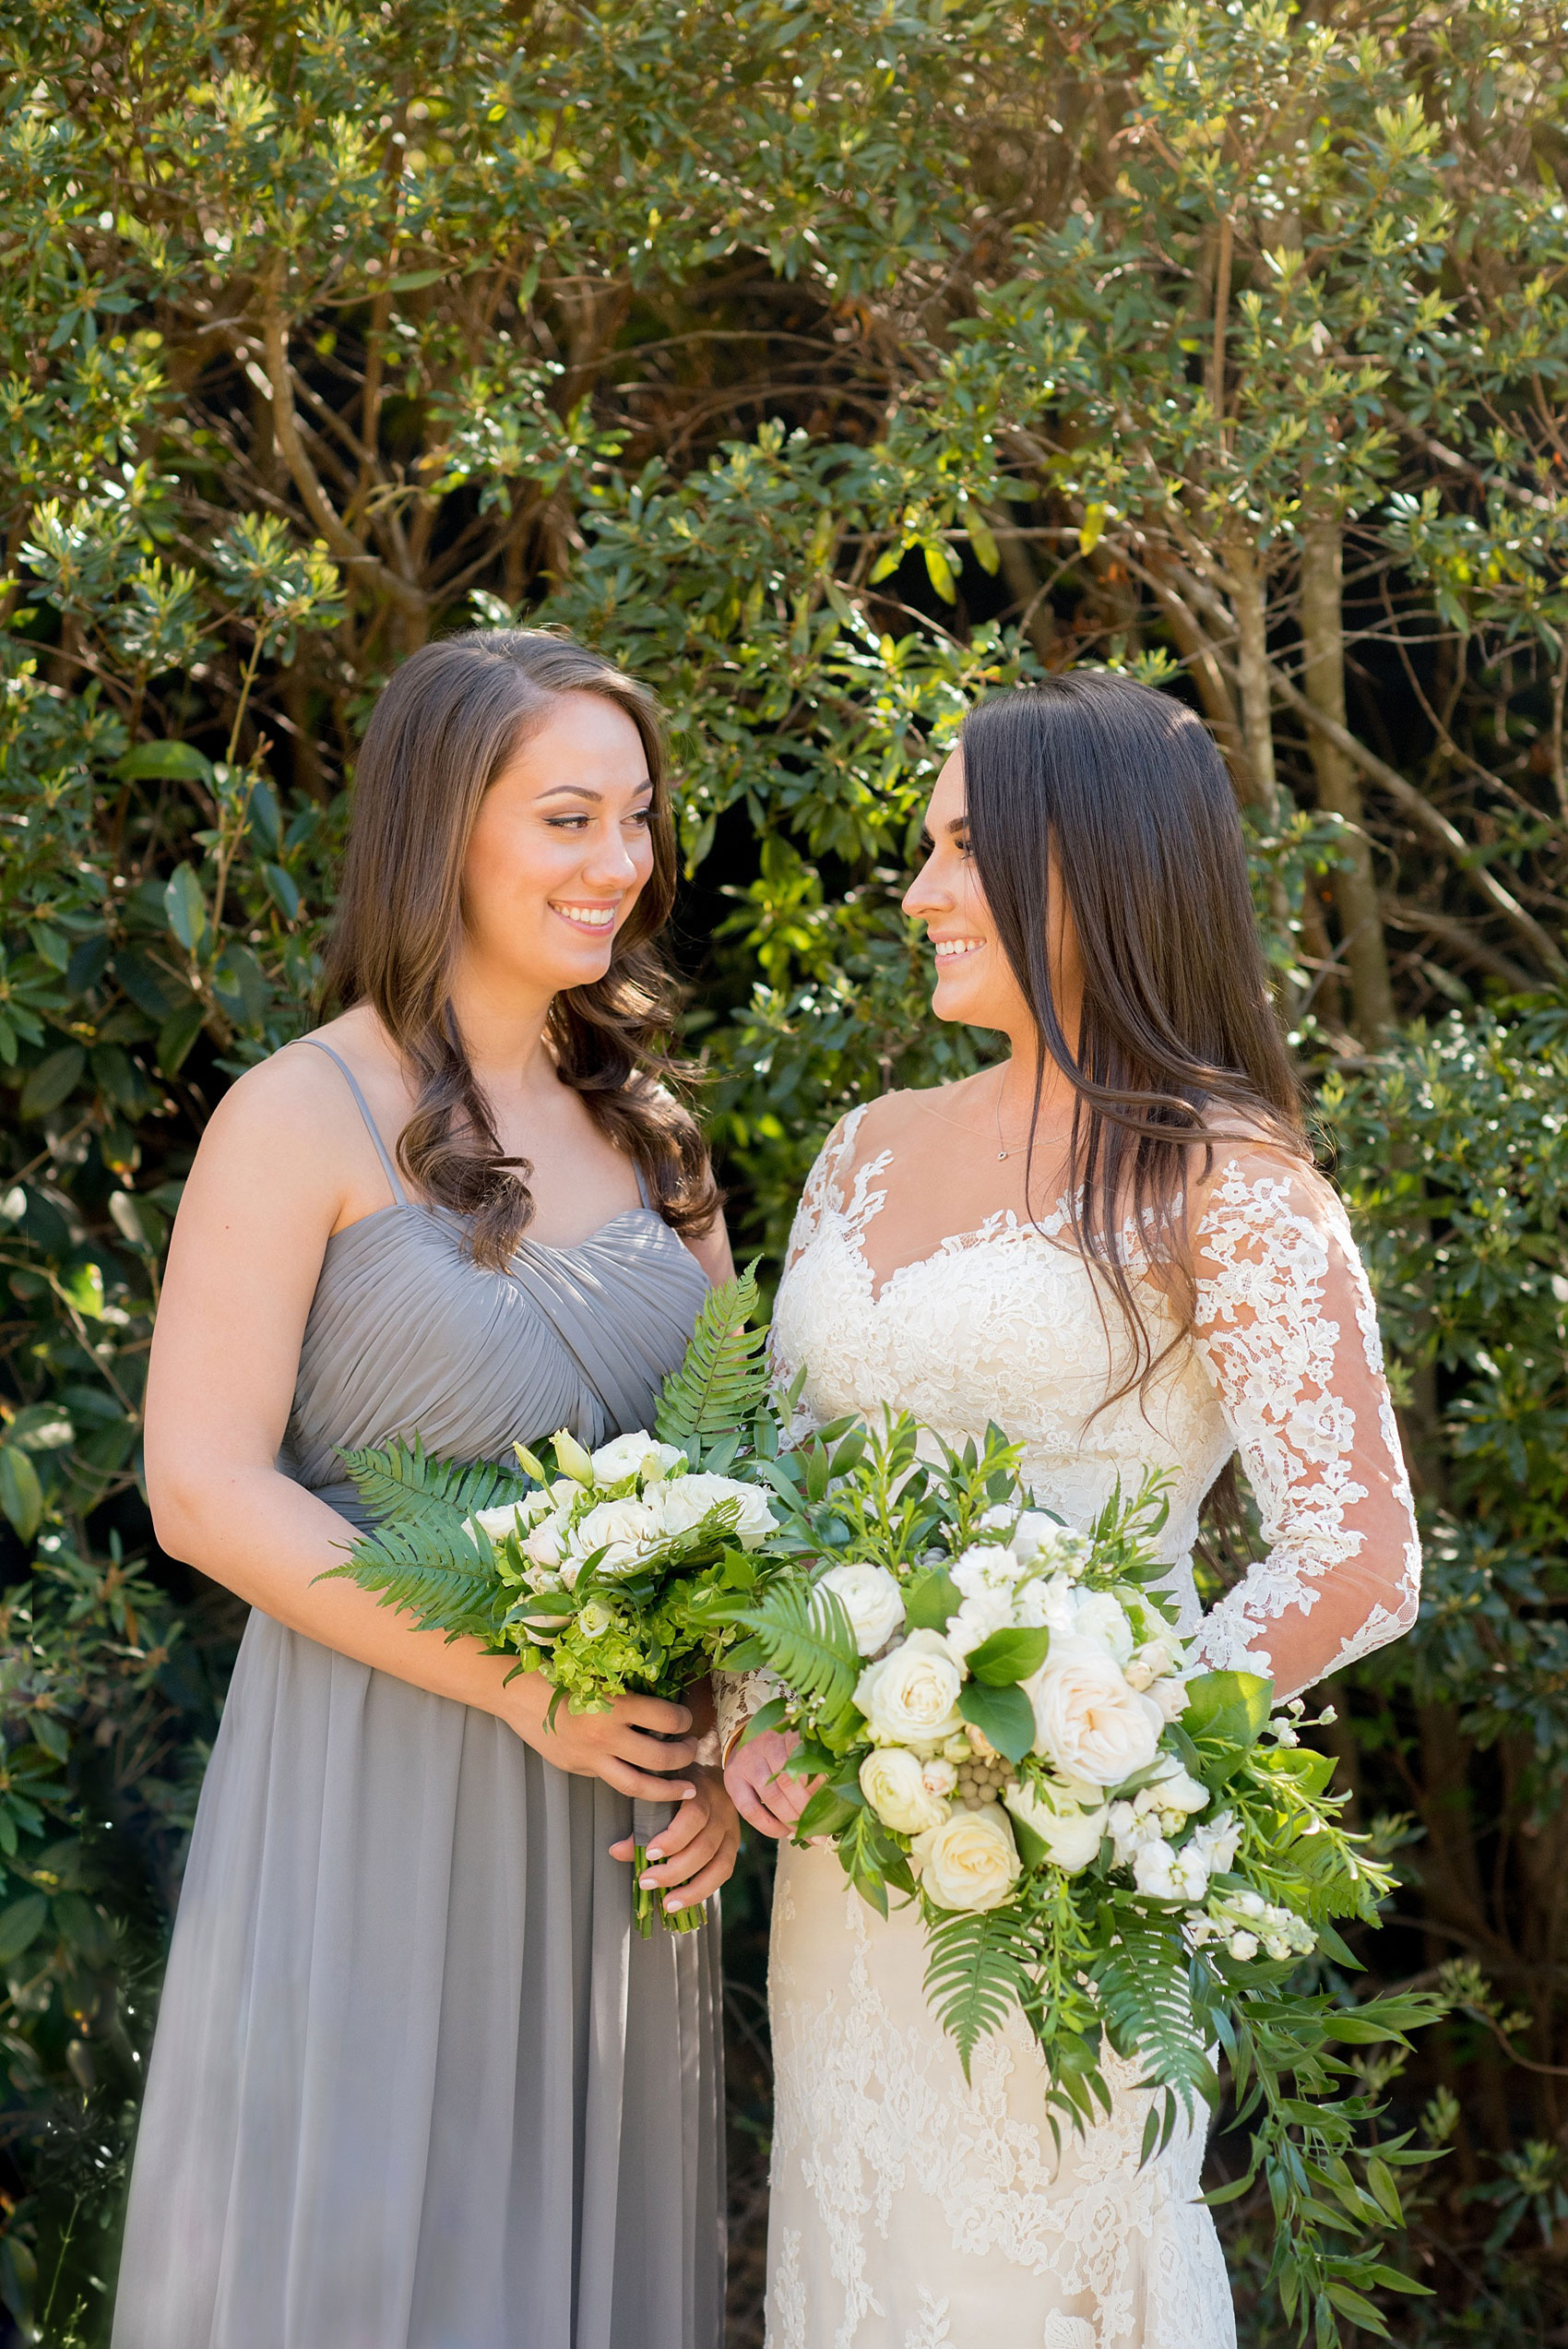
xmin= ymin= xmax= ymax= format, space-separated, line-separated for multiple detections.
xmin=331 ymin=1270 xmax=775 ymax=1936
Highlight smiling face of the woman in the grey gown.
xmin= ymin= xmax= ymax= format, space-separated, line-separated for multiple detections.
xmin=462 ymin=693 xmax=652 ymax=996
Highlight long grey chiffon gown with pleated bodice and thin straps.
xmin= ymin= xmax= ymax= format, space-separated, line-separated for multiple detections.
xmin=113 ymin=1038 xmax=723 ymax=2349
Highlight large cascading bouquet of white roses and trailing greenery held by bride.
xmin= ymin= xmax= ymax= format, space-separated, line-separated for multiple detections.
xmin=730 ymin=1414 xmax=1442 ymax=2340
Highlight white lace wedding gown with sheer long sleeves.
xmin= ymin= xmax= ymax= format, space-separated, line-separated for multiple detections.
xmin=720 ymin=1094 xmax=1420 ymax=2349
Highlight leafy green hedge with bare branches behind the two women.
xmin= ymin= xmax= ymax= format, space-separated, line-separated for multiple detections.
xmin=0 ymin=0 xmax=1568 ymax=2349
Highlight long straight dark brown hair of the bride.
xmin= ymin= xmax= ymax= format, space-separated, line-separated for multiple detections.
xmin=962 ymin=672 xmax=1310 ymax=1400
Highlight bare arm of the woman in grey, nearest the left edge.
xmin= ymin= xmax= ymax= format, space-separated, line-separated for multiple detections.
xmin=146 ymin=1053 xmax=695 ymax=1799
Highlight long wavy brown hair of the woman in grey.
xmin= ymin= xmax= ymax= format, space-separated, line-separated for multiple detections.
xmin=322 ymin=627 xmax=720 ymax=1269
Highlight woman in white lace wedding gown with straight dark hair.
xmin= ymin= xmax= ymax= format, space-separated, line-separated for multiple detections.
xmin=720 ymin=674 xmax=1420 ymax=2349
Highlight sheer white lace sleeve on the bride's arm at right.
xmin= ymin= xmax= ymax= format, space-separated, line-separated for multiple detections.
xmin=1194 ymin=1151 xmax=1420 ymax=1696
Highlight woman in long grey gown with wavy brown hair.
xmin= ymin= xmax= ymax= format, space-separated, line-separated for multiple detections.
xmin=113 ymin=632 xmax=737 ymax=2349
